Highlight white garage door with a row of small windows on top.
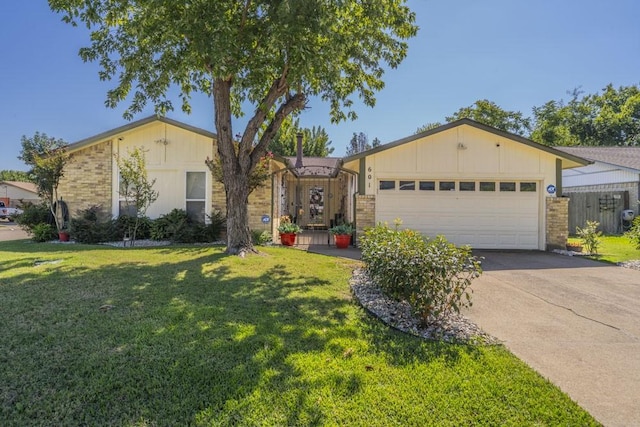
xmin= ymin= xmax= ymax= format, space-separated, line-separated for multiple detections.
xmin=376 ymin=180 xmax=540 ymax=249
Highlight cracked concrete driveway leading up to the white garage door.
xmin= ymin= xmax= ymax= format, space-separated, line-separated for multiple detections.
xmin=465 ymin=251 xmax=640 ymax=426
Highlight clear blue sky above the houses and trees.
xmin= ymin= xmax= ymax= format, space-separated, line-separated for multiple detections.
xmin=0 ymin=0 xmax=640 ymax=170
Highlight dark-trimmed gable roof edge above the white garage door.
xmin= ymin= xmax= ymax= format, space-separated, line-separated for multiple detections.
xmin=343 ymin=118 xmax=591 ymax=166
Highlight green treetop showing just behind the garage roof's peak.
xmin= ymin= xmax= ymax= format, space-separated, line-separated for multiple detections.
xmin=445 ymin=99 xmax=531 ymax=136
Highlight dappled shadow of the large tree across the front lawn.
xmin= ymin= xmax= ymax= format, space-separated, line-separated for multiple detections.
xmin=0 ymin=247 xmax=488 ymax=425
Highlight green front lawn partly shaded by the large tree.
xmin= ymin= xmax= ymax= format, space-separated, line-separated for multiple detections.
xmin=0 ymin=241 xmax=597 ymax=426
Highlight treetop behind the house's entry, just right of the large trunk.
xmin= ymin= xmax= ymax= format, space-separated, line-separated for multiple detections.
xmin=269 ymin=116 xmax=334 ymax=157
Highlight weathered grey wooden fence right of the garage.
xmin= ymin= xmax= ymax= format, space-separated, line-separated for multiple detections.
xmin=565 ymin=191 xmax=629 ymax=234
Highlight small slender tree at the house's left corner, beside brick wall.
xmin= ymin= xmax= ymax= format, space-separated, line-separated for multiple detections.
xmin=18 ymin=132 xmax=69 ymax=231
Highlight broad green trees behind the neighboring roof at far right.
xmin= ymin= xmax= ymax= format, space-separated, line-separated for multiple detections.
xmin=531 ymin=84 xmax=640 ymax=146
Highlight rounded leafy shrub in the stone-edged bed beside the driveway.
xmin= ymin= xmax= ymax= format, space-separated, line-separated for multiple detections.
xmin=360 ymin=223 xmax=482 ymax=325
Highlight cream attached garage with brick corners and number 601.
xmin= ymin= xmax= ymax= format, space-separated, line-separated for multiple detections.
xmin=344 ymin=119 xmax=588 ymax=250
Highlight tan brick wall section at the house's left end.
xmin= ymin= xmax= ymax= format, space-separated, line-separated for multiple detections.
xmin=58 ymin=141 xmax=113 ymax=217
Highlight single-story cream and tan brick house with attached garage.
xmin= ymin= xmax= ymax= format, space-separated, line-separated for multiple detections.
xmin=59 ymin=116 xmax=588 ymax=250
